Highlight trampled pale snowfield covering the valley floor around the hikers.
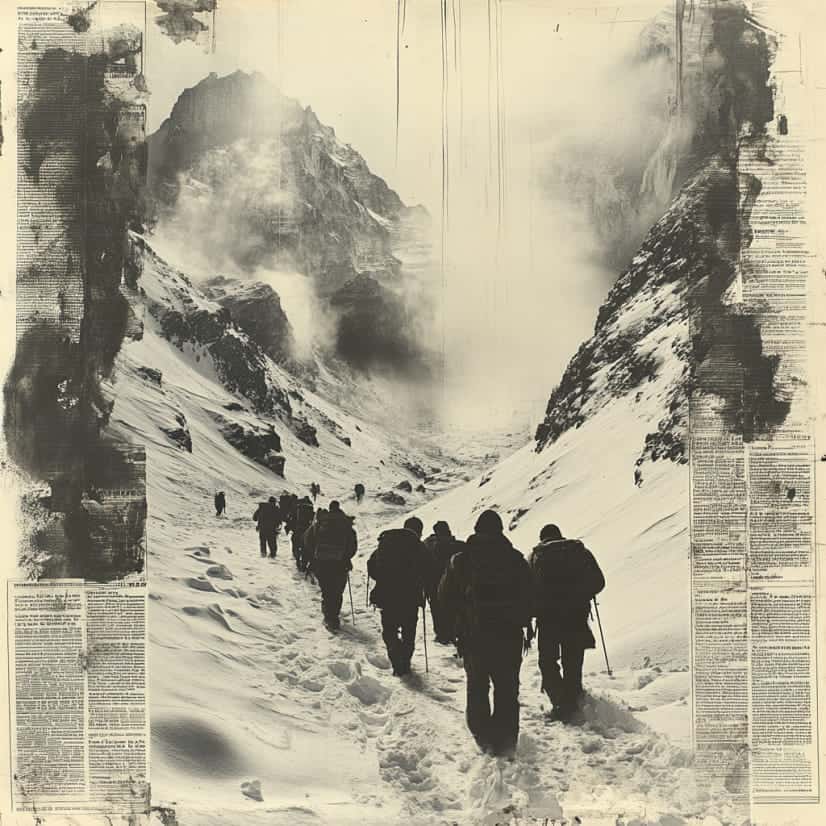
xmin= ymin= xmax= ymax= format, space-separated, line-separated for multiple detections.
xmin=112 ymin=240 xmax=740 ymax=826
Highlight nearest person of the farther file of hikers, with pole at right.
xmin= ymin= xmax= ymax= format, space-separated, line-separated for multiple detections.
xmin=305 ymin=500 xmax=358 ymax=631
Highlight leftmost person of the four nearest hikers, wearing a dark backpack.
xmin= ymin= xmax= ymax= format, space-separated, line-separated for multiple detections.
xmin=367 ymin=516 xmax=429 ymax=677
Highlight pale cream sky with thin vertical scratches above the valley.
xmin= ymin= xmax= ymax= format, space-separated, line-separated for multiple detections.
xmin=146 ymin=0 xmax=671 ymax=424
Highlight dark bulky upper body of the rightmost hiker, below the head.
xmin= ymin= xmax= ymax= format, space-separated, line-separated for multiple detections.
xmin=530 ymin=539 xmax=605 ymax=648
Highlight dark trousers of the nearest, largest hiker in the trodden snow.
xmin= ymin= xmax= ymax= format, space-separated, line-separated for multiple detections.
xmin=462 ymin=628 xmax=522 ymax=754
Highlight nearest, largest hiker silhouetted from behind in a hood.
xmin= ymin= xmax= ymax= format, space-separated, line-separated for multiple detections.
xmin=439 ymin=510 xmax=532 ymax=756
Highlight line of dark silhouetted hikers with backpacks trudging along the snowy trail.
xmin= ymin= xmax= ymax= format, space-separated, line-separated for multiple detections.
xmin=241 ymin=492 xmax=605 ymax=756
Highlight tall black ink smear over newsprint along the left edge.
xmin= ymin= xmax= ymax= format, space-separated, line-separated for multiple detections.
xmin=4 ymin=33 xmax=146 ymax=581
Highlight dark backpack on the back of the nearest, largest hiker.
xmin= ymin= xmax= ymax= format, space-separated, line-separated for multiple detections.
xmin=465 ymin=554 xmax=530 ymax=631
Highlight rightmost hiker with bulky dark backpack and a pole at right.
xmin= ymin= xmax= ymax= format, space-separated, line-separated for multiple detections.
xmin=530 ymin=525 xmax=605 ymax=722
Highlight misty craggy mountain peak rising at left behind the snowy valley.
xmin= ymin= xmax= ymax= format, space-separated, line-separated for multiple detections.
xmin=149 ymin=72 xmax=429 ymax=369
